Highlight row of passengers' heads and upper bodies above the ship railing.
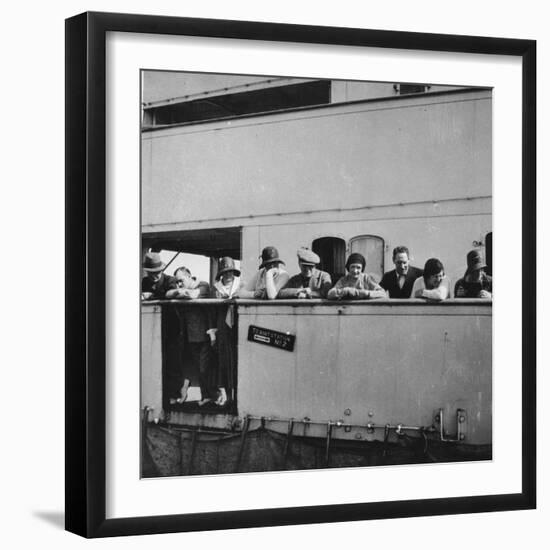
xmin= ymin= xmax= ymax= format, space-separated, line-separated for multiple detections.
xmin=142 ymin=246 xmax=493 ymax=301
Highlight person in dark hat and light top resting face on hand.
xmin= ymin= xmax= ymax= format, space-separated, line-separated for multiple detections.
xmin=239 ymin=246 xmax=289 ymax=300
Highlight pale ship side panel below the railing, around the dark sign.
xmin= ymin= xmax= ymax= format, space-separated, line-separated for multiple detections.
xmin=238 ymin=303 xmax=492 ymax=444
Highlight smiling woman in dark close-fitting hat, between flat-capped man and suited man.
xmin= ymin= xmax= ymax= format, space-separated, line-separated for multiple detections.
xmin=327 ymin=252 xmax=387 ymax=300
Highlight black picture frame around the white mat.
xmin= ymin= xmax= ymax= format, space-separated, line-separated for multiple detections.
xmin=65 ymin=13 xmax=536 ymax=537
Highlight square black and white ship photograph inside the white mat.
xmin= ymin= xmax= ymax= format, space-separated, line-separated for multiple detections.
xmin=142 ymin=70 xmax=496 ymax=478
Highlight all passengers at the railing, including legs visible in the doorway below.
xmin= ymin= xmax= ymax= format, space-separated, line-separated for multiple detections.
xmin=142 ymin=246 xmax=492 ymax=406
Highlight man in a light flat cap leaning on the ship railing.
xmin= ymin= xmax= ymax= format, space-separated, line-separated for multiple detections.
xmin=278 ymin=248 xmax=332 ymax=299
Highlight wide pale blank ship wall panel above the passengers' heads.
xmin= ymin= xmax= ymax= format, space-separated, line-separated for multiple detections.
xmin=142 ymin=92 xmax=491 ymax=231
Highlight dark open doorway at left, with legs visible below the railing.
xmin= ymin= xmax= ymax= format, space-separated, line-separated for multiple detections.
xmin=142 ymin=227 xmax=241 ymax=413
